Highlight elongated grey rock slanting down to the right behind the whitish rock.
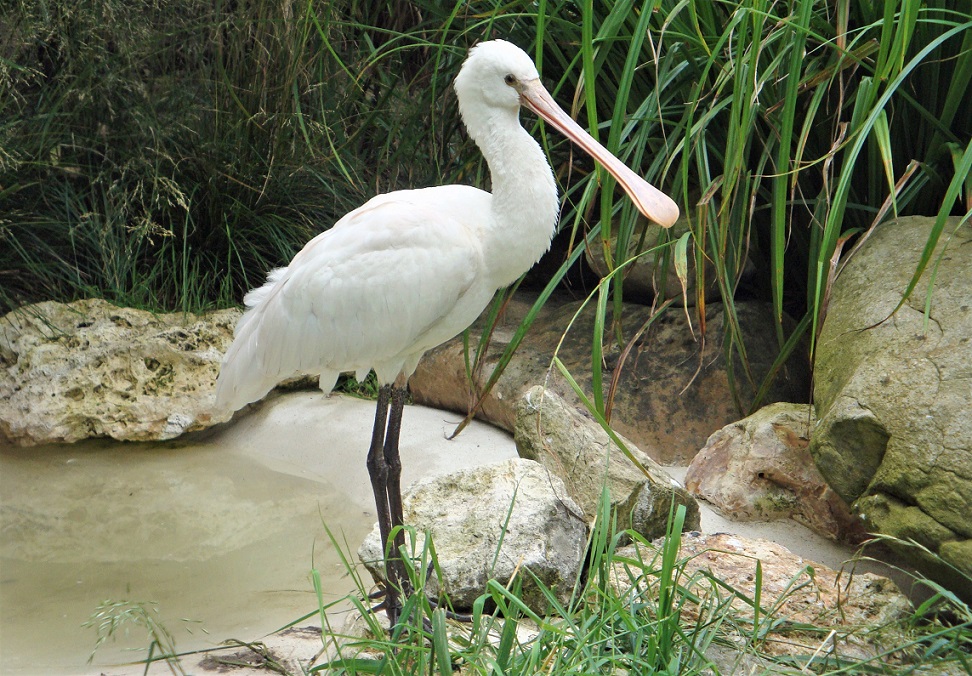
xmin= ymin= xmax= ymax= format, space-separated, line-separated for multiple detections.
xmin=513 ymin=386 xmax=699 ymax=540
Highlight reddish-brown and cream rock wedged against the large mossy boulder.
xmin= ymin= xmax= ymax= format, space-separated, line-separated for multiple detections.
xmin=685 ymin=403 xmax=866 ymax=544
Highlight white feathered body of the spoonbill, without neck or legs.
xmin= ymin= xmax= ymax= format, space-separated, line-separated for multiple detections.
xmin=217 ymin=186 xmax=494 ymax=410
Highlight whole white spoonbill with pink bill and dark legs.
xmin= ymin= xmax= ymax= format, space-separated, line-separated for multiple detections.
xmin=216 ymin=40 xmax=678 ymax=625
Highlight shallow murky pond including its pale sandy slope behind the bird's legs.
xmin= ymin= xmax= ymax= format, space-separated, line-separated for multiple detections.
xmin=0 ymin=393 xmax=516 ymax=674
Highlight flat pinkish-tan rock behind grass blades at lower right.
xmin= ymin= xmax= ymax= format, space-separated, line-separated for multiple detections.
xmin=612 ymin=533 xmax=911 ymax=660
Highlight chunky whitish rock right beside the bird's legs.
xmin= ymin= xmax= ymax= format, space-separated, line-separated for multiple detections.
xmin=358 ymin=458 xmax=587 ymax=613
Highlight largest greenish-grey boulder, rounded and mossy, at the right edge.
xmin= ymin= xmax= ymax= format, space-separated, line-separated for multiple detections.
xmin=810 ymin=218 xmax=972 ymax=596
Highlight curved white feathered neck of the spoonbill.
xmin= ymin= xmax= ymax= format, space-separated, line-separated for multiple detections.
xmin=474 ymin=111 xmax=560 ymax=288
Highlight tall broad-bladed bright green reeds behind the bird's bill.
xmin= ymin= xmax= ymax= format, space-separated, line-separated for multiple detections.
xmin=474 ymin=0 xmax=972 ymax=418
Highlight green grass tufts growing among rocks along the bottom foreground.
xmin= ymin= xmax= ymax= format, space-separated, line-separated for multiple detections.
xmin=89 ymin=500 xmax=972 ymax=676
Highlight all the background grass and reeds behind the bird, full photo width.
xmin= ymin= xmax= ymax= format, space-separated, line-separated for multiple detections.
xmin=0 ymin=0 xmax=972 ymax=394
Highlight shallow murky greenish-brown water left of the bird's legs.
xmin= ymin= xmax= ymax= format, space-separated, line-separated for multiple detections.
xmin=0 ymin=443 xmax=364 ymax=673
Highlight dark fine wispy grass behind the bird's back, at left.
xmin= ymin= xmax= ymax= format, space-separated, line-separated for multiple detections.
xmin=0 ymin=0 xmax=452 ymax=310
